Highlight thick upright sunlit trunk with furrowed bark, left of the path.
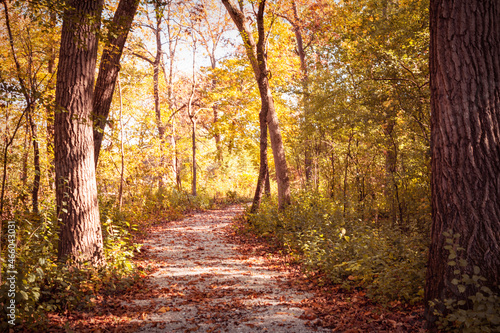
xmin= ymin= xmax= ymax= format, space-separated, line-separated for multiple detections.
xmin=54 ymin=0 xmax=105 ymax=266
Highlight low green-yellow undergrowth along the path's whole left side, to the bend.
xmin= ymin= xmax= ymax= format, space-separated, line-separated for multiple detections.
xmin=0 ymin=190 xmax=246 ymax=332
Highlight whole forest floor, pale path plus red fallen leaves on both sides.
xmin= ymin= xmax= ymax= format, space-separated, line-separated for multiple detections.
xmin=47 ymin=206 xmax=424 ymax=333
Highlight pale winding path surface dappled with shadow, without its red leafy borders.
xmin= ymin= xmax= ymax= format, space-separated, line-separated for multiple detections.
xmin=129 ymin=206 xmax=325 ymax=332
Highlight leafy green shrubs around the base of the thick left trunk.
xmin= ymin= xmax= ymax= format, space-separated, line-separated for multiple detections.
xmin=0 ymin=205 xmax=145 ymax=331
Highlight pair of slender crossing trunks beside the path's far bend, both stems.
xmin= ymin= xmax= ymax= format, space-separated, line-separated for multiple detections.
xmin=222 ymin=0 xmax=290 ymax=211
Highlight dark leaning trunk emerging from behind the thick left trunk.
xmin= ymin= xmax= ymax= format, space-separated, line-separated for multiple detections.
xmin=93 ymin=0 xmax=139 ymax=166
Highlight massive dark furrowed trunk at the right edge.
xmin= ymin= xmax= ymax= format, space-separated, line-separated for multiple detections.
xmin=425 ymin=0 xmax=500 ymax=328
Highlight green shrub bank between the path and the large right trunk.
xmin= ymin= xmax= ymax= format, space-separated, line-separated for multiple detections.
xmin=248 ymin=192 xmax=427 ymax=303
